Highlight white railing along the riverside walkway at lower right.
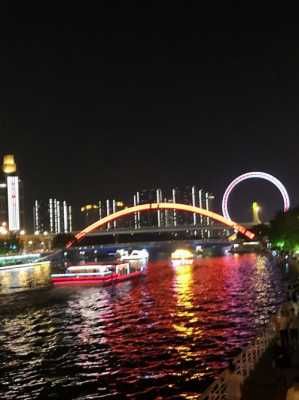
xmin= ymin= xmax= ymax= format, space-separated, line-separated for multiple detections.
xmin=200 ymin=320 xmax=276 ymax=400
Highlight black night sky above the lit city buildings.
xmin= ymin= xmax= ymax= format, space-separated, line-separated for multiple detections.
xmin=0 ymin=7 xmax=299 ymax=225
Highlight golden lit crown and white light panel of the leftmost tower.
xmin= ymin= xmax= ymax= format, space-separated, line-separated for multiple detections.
xmin=2 ymin=154 xmax=21 ymax=232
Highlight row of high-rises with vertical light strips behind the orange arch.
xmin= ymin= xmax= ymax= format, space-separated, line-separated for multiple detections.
xmin=30 ymin=185 xmax=215 ymax=233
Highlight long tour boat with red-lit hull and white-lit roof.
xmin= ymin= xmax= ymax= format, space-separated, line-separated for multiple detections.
xmin=51 ymin=263 xmax=144 ymax=285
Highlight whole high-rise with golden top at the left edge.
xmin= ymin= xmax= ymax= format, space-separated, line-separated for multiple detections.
xmin=0 ymin=154 xmax=24 ymax=232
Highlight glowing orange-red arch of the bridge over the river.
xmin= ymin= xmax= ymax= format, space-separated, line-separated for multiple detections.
xmin=66 ymin=203 xmax=254 ymax=248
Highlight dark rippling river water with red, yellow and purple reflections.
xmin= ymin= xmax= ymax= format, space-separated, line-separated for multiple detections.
xmin=0 ymin=254 xmax=283 ymax=400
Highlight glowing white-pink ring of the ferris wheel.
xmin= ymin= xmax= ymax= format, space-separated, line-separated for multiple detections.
xmin=222 ymin=172 xmax=290 ymax=220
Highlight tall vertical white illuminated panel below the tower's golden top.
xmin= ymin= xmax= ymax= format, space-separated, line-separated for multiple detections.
xmin=7 ymin=176 xmax=20 ymax=231
